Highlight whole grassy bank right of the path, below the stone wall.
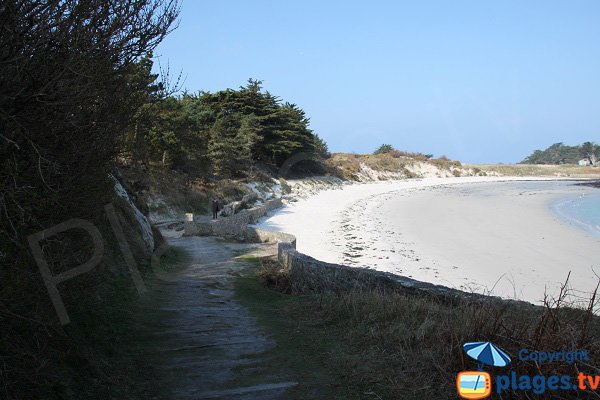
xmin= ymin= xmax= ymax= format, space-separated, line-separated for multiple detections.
xmin=236 ymin=258 xmax=600 ymax=399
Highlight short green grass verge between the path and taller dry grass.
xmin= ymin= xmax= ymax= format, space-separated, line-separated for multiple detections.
xmin=235 ymin=268 xmax=346 ymax=399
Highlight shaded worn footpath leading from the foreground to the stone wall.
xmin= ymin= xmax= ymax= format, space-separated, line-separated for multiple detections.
xmin=135 ymin=232 xmax=295 ymax=400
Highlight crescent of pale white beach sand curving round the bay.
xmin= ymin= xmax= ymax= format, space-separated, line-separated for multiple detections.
xmin=260 ymin=177 xmax=600 ymax=303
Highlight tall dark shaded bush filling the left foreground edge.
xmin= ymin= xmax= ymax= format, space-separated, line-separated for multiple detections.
xmin=0 ymin=0 xmax=179 ymax=399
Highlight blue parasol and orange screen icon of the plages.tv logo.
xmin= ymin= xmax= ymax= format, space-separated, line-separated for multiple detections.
xmin=456 ymin=342 xmax=510 ymax=399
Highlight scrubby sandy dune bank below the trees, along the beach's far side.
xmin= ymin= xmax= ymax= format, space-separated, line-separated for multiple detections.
xmin=120 ymin=153 xmax=598 ymax=227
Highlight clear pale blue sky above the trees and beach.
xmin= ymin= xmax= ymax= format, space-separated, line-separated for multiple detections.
xmin=154 ymin=0 xmax=600 ymax=163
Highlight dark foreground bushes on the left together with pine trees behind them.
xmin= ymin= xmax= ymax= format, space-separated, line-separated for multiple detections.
xmin=0 ymin=0 xmax=328 ymax=399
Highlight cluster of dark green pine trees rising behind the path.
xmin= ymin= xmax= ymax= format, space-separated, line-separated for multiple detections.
xmin=125 ymin=78 xmax=329 ymax=178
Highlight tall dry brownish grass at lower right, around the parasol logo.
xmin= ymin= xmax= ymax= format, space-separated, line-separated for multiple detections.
xmin=321 ymin=286 xmax=600 ymax=399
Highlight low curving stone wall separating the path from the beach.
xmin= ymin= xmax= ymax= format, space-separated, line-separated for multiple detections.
xmin=185 ymin=199 xmax=490 ymax=300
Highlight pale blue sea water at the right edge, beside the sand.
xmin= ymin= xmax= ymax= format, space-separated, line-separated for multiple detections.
xmin=550 ymin=189 xmax=600 ymax=237
